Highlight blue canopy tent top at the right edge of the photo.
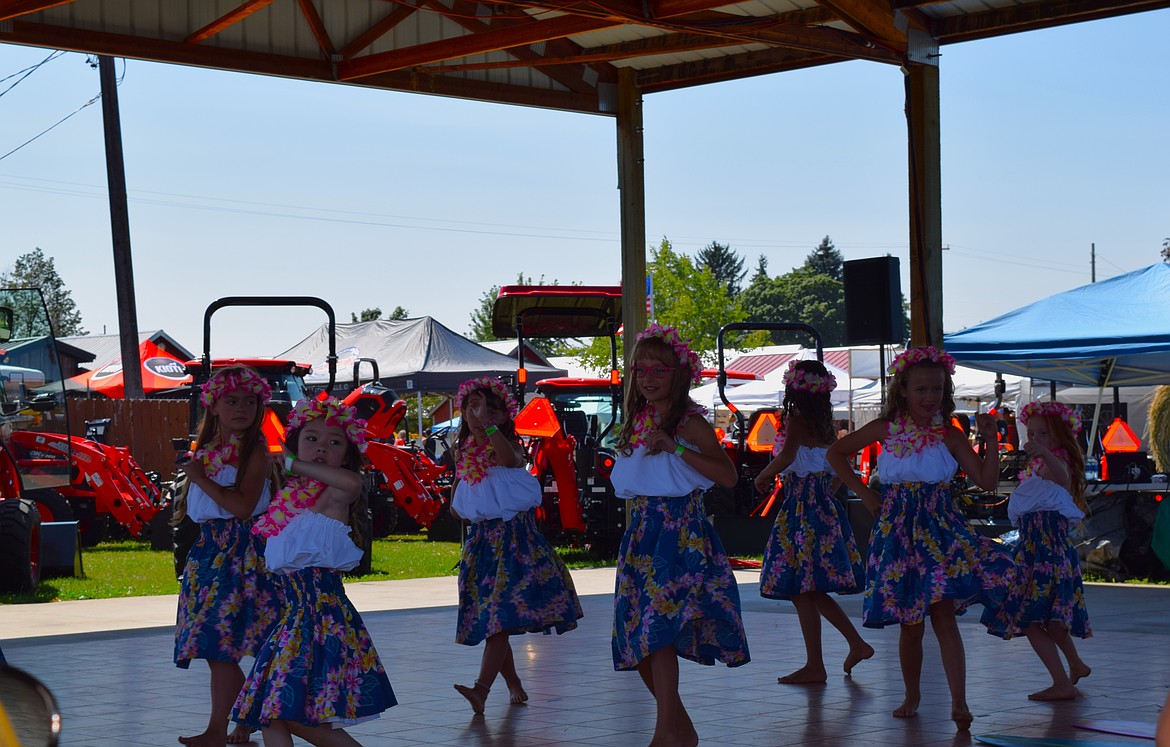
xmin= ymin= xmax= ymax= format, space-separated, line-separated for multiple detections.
xmin=943 ymin=262 xmax=1170 ymax=386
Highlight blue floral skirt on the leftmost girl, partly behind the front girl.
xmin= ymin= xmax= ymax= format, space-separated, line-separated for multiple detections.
xmin=174 ymin=519 xmax=281 ymax=669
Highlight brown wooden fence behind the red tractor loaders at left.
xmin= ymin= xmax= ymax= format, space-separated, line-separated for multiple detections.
xmin=66 ymin=397 xmax=191 ymax=479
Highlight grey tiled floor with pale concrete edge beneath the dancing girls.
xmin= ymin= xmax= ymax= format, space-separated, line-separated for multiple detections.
xmin=0 ymin=569 xmax=1170 ymax=747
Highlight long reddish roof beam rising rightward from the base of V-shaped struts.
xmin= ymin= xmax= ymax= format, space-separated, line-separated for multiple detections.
xmin=338 ymin=15 xmax=620 ymax=81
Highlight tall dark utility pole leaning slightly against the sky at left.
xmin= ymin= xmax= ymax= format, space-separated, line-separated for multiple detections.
xmin=97 ymin=55 xmax=145 ymax=399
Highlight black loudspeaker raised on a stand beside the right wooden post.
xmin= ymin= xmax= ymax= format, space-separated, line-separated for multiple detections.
xmin=842 ymin=256 xmax=904 ymax=345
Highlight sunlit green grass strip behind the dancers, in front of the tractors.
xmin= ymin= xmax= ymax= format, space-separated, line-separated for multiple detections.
xmin=0 ymin=534 xmax=613 ymax=604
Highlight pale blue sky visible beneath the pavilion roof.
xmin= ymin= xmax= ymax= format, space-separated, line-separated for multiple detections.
xmin=0 ymin=11 xmax=1170 ymax=355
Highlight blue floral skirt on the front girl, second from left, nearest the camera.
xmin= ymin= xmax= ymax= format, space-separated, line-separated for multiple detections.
xmin=232 ymin=568 xmax=398 ymax=729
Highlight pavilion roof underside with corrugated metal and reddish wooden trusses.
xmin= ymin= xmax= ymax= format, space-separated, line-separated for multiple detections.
xmin=0 ymin=0 xmax=1170 ymax=114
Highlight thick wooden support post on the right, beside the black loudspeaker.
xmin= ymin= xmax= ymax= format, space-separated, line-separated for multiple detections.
xmin=903 ymin=57 xmax=943 ymax=345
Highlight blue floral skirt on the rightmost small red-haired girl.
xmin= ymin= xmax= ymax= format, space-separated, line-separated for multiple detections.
xmin=982 ymin=510 xmax=1093 ymax=638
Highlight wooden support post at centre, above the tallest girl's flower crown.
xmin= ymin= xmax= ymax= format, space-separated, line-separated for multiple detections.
xmin=618 ymin=68 xmax=646 ymax=370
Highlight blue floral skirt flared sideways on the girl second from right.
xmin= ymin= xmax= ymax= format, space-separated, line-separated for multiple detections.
xmin=861 ymin=482 xmax=1016 ymax=628
